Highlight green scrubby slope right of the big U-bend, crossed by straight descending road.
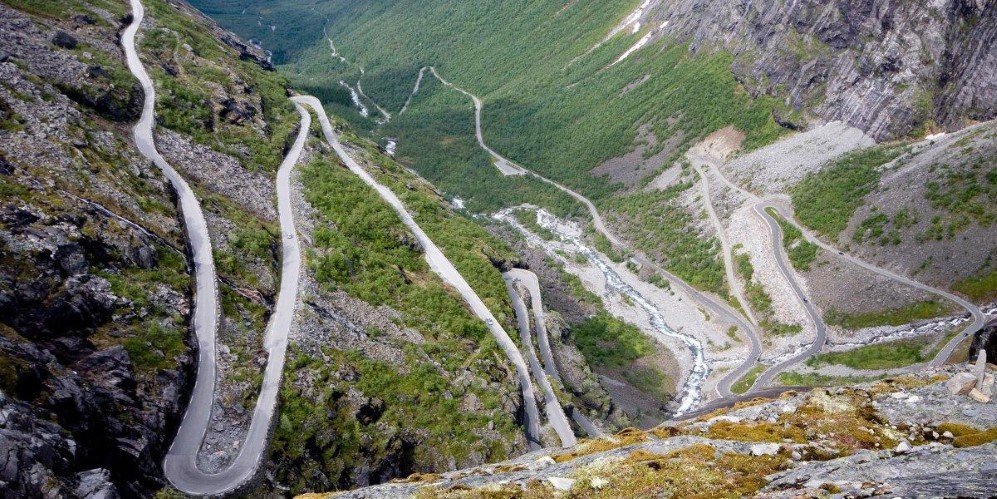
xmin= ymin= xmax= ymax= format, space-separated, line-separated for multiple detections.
xmin=260 ymin=119 xmax=526 ymax=490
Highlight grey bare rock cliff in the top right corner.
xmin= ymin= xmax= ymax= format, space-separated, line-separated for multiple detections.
xmin=645 ymin=0 xmax=997 ymax=140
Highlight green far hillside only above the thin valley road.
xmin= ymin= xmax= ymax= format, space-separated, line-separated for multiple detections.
xmin=189 ymin=0 xmax=781 ymax=201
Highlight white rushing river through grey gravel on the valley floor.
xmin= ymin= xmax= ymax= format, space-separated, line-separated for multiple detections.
xmin=494 ymin=205 xmax=710 ymax=416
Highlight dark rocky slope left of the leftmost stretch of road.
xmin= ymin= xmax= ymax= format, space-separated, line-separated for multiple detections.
xmin=0 ymin=6 xmax=191 ymax=497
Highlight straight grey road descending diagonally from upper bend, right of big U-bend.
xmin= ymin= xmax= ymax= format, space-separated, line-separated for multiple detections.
xmin=291 ymin=96 xmax=567 ymax=450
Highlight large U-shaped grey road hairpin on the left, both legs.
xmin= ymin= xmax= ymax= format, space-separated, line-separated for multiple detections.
xmin=121 ymin=0 xmax=311 ymax=495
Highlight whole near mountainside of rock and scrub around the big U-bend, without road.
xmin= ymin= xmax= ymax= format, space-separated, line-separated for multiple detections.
xmin=0 ymin=0 xmax=554 ymax=497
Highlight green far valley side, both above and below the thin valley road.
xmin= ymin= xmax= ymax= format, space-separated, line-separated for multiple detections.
xmin=189 ymin=0 xmax=783 ymax=292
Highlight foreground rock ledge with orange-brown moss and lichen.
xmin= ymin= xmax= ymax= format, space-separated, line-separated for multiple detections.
xmin=298 ymin=365 xmax=997 ymax=499
